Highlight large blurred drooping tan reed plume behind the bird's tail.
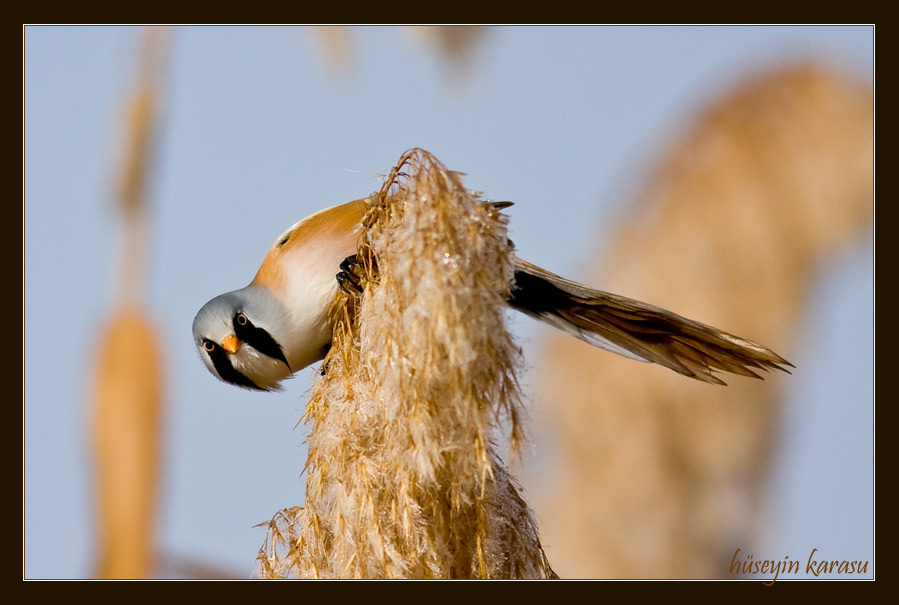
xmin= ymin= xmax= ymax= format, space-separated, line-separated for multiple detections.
xmin=531 ymin=65 xmax=874 ymax=578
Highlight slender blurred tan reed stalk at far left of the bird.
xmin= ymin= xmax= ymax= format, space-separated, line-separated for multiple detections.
xmin=92 ymin=28 xmax=168 ymax=578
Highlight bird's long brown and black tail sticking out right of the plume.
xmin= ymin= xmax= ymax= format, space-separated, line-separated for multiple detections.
xmin=509 ymin=259 xmax=794 ymax=384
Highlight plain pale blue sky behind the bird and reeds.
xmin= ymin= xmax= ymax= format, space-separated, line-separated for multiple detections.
xmin=23 ymin=27 xmax=874 ymax=578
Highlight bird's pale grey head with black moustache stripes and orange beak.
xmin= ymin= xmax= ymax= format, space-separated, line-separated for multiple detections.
xmin=193 ymin=285 xmax=293 ymax=391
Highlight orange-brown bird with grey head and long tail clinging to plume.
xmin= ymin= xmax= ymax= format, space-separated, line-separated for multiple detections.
xmin=193 ymin=200 xmax=793 ymax=391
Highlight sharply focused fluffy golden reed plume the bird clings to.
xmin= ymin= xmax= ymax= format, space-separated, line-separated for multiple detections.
xmin=258 ymin=150 xmax=553 ymax=578
